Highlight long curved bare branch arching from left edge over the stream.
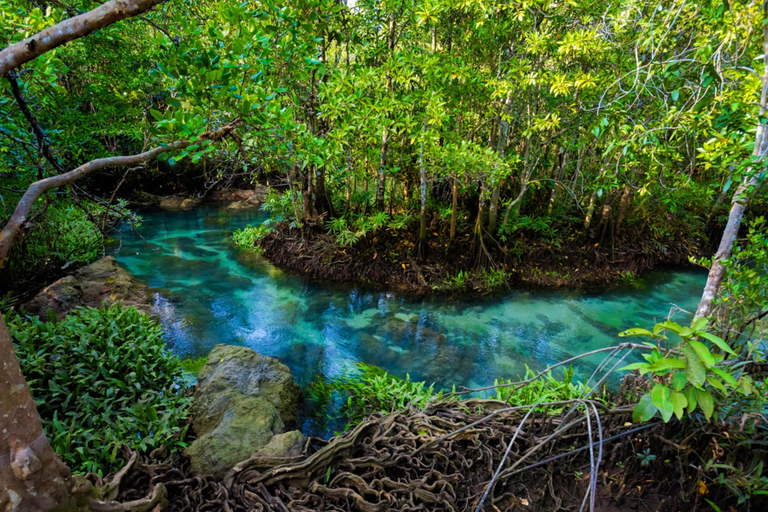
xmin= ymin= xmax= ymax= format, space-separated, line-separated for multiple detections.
xmin=0 ymin=119 xmax=240 ymax=271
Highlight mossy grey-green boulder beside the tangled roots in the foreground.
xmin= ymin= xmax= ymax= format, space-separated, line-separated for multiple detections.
xmin=185 ymin=345 xmax=304 ymax=477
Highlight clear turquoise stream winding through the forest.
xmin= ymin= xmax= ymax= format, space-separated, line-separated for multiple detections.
xmin=113 ymin=206 xmax=706 ymax=431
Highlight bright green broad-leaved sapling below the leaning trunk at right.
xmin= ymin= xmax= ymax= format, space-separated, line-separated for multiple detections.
xmin=619 ymin=318 xmax=754 ymax=421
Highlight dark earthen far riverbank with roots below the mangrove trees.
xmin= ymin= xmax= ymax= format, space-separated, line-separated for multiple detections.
xmin=256 ymin=222 xmax=702 ymax=295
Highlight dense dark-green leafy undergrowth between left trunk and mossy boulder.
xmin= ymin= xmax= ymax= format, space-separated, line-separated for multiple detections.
xmin=5 ymin=304 xmax=189 ymax=474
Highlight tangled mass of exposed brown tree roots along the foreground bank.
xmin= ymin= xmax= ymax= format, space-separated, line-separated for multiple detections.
xmin=103 ymin=400 xmax=680 ymax=512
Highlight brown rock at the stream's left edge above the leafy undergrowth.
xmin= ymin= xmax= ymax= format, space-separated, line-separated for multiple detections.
xmin=24 ymin=256 xmax=152 ymax=319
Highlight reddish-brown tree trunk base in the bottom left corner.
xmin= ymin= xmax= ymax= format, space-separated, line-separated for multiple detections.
xmin=0 ymin=314 xmax=73 ymax=512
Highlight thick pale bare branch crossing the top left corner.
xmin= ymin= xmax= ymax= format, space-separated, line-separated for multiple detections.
xmin=0 ymin=0 xmax=165 ymax=76
